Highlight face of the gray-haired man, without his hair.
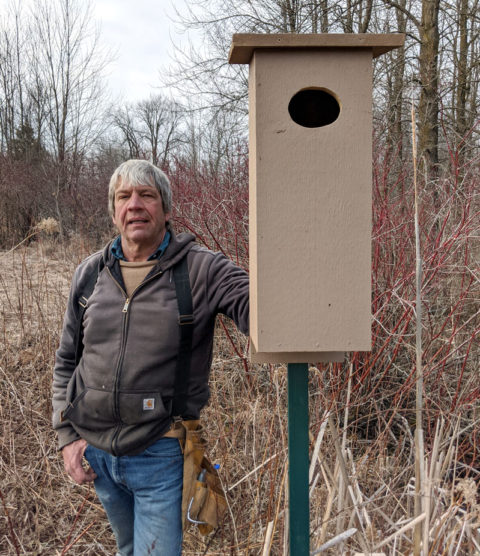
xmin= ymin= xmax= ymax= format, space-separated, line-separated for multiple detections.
xmin=113 ymin=183 xmax=170 ymax=248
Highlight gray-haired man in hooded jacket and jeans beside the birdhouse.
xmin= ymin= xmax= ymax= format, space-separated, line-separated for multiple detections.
xmin=53 ymin=160 xmax=249 ymax=556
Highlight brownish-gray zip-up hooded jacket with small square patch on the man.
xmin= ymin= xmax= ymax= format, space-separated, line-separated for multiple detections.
xmin=53 ymin=232 xmax=249 ymax=455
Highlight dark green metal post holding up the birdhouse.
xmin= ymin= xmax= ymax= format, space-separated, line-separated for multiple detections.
xmin=288 ymin=363 xmax=310 ymax=556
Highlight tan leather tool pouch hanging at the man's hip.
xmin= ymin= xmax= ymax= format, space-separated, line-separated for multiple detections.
xmin=180 ymin=420 xmax=227 ymax=535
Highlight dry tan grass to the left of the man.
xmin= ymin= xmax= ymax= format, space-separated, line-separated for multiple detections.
xmin=0 ymin=243 xmax=114 ymax=554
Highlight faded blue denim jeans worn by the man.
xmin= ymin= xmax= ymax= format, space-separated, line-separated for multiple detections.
xmin=85 ymin=438 xmax=183 ymax=556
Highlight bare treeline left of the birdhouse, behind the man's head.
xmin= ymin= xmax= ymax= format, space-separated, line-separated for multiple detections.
xmin=0 ymin=0 xmax=247 ymax=248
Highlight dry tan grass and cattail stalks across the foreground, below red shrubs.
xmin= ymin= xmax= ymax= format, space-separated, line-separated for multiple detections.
xmin=0 ymin=244 xmax=480 ymax=555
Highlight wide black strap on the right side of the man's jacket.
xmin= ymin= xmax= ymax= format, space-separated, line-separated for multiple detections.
xmin=172 ymin=256 xmax=193 ymax=419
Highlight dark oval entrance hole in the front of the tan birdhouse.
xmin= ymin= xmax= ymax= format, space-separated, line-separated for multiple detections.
xmin=288 ymin=88 xmax=340 ymax=127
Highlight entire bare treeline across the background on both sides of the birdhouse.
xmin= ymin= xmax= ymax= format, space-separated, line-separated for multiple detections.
xmin=0 ymin=0 xmax=480 ymax=247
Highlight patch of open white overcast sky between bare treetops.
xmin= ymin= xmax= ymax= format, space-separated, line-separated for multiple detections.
xmin=92 ymin=0 xmax=192 ymax=101
